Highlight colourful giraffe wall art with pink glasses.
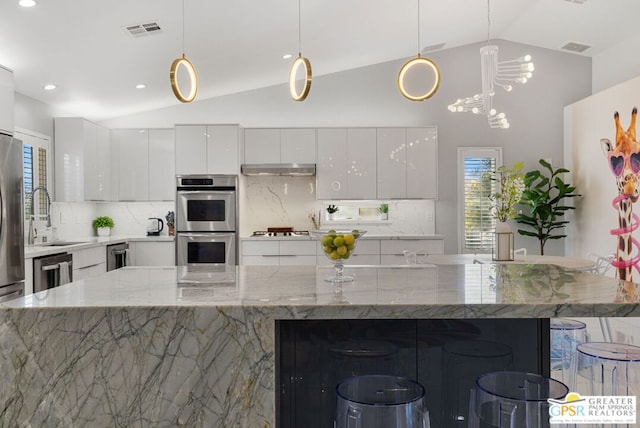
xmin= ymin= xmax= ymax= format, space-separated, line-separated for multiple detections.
xmin=600 ymin=107 xmax=640 ymax=281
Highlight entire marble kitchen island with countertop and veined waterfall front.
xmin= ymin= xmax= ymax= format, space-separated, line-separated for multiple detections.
xmin=0 ymin=264 xmax=640 ymax=427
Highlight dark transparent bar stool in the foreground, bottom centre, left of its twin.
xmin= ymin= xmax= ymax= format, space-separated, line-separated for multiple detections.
xmin=335 ymin=375 xmax=430 ymax=428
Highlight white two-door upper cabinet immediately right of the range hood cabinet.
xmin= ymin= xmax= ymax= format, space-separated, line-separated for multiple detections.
xmin=317 ymin=128 xmax=376 ymax=199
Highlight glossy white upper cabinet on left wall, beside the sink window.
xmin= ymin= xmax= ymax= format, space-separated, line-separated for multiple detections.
xmin=54 ymin=117 xmax=111 ymax=202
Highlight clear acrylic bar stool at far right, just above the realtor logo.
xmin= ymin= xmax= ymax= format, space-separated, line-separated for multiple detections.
xmin=573 ymin=342 xmax=640 ymax=428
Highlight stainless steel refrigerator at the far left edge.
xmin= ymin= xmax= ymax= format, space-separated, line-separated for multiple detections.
xmin=0 ymin=133 xmax=24 ymax=302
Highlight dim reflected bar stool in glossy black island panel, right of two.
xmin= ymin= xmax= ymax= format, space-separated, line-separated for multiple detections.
xmin=442 ymin=340 xmax=513 ymax=427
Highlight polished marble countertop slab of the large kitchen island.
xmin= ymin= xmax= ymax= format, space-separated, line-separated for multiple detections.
xmin=6 ymin=264 xmax=640 ymax=318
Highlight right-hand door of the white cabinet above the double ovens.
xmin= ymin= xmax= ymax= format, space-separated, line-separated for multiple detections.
xmin=207 ymin=125 xmax=240 ymax=175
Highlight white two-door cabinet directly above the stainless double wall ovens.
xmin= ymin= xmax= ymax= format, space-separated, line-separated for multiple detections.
xmin=174 ymin=125 xmax=240 ymax=175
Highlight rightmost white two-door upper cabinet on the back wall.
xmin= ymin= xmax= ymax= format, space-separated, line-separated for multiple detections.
xmin=377 ymin=127 xmax=438 ymax=199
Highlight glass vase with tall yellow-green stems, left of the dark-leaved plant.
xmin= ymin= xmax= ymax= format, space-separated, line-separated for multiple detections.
xmin=489 ymin=162 xmax=524 ymax=260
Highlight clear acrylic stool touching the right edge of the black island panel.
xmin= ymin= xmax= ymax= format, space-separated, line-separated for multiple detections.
xmin=550 ymin=318 xmax=589 ymax=390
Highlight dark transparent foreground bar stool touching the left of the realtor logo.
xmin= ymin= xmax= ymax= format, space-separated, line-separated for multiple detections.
xmin=469 ymin=372 xmax=569 ymax=428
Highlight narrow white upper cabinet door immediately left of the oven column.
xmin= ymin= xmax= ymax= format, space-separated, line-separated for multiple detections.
xmin=149 ymin=129 xmax=176 ymax=201
